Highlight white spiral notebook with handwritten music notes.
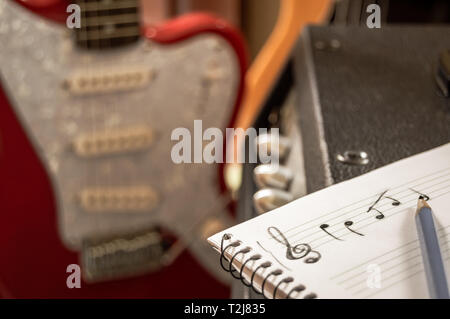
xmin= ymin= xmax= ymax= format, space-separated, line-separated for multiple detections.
xmin=208 ymin=144 xmax=450 ymax=298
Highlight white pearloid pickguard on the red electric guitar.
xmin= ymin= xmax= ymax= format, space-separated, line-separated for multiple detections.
xmin=0 ymin=0 xmax=239 ymax=282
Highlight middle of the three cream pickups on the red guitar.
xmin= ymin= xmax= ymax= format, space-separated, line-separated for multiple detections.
xmin=73 ymin=126 xmax=154 ymax=158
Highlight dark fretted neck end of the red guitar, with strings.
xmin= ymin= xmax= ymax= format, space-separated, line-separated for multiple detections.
xmin=74 ymin=0 xmax=140 ymax=50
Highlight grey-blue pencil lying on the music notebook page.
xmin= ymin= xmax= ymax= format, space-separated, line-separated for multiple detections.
xmin=415 ymin=196 xmax=449 ymax=299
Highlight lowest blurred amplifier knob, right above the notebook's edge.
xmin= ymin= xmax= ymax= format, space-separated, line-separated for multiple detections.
xmin=253 ymin=188 xmax=294 ymax=214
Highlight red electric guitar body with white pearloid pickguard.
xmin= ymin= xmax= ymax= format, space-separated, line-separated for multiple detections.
xmin=0 ymin=0 xmax=245 ymax=298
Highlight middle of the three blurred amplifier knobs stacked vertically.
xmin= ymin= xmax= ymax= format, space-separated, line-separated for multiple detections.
xmin=253 ymin=164 xmax=294 ymax=190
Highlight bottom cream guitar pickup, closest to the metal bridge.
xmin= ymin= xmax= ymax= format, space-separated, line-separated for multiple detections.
xmin=79 ymin=186 xmax=158 ymax=213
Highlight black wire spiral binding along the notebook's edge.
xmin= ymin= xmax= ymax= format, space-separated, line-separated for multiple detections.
xmin=220 ymin=234 xmax=317 ymax=299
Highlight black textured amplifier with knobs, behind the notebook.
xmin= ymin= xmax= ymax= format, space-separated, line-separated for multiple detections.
xmin=233 ymin=25 xmax=450 ymax=297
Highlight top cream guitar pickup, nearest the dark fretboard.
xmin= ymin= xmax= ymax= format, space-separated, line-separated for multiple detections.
xmin=63 ymin=69 xmax=153 ymax=95
